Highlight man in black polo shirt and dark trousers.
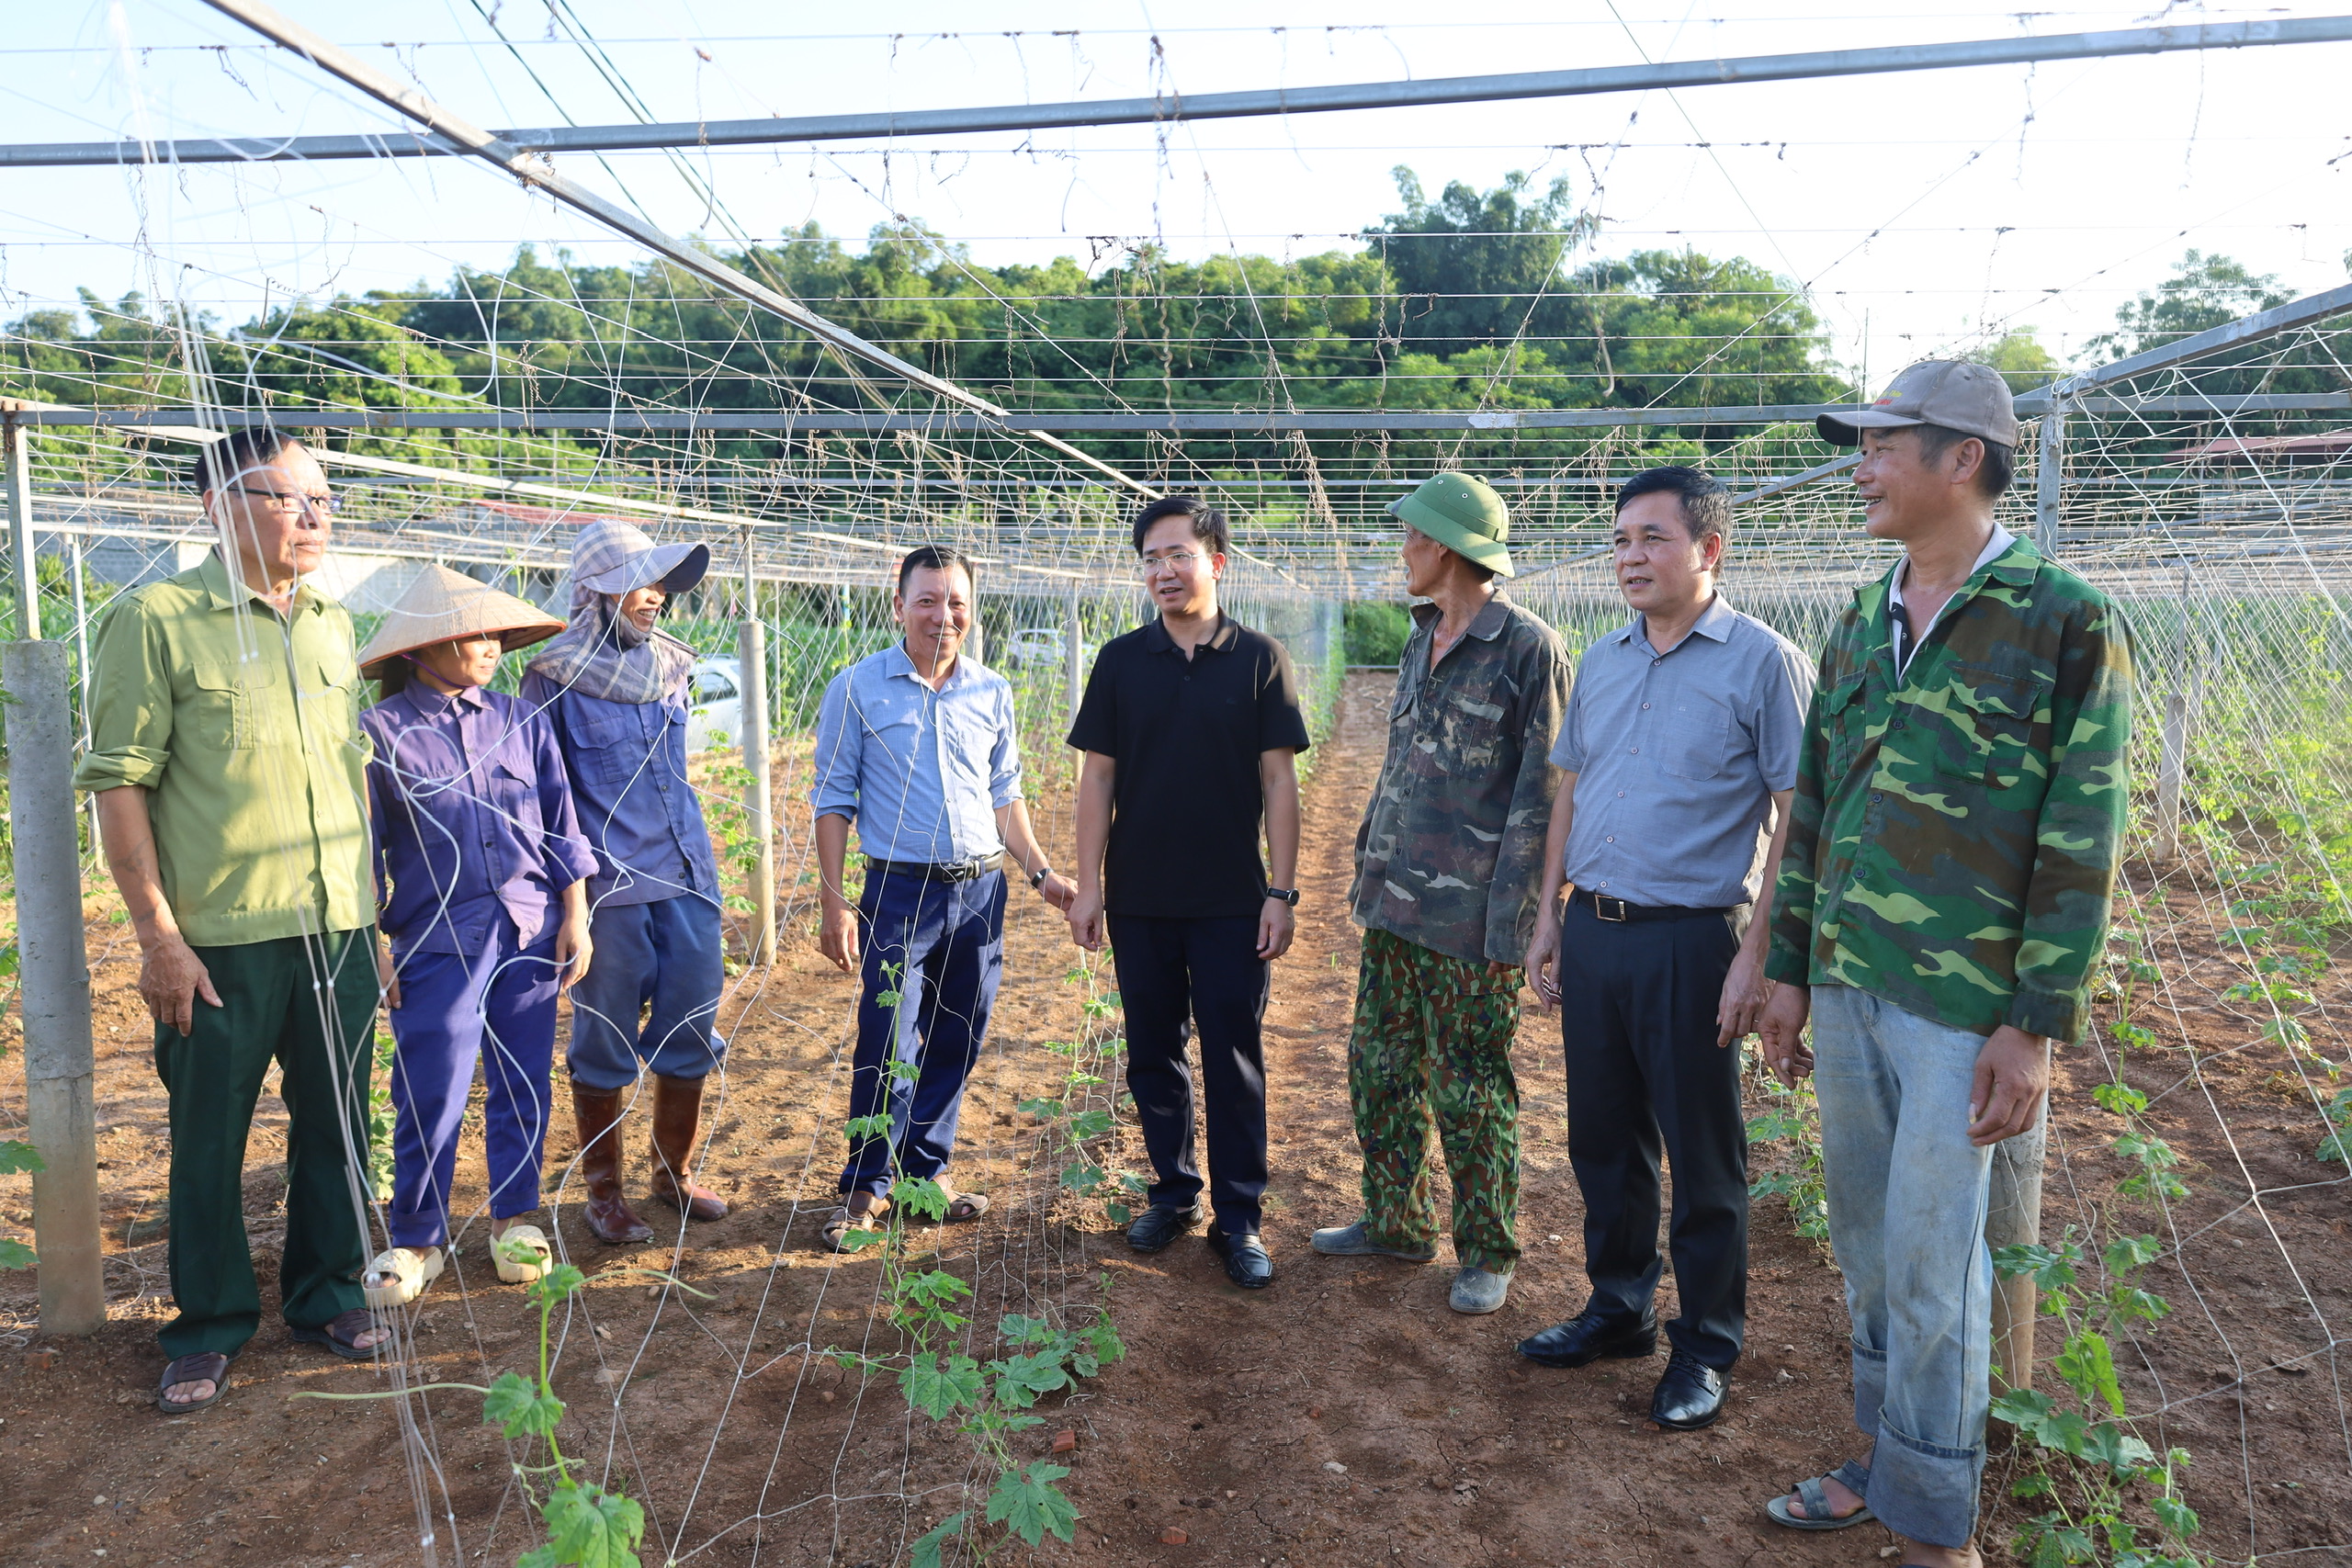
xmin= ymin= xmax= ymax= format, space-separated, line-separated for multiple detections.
xmin=1070 ymin=496 xmax=1307 ymax=1288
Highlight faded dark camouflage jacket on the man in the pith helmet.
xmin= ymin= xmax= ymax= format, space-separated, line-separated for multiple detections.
xmin=1348 ymin=592 xmax=1569 ymax=964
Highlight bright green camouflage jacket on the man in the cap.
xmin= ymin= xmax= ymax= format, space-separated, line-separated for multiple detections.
xmin=1767 ymin=541 xmax=2131 ymax=1042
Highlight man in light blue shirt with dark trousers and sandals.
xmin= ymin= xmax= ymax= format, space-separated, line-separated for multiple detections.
xmin=809 ymin=546 xmax=1077 ymax=1251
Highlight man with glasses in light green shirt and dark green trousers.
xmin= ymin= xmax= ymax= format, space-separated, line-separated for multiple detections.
xmin=75 ymin=430 xmax=388 ymax=1416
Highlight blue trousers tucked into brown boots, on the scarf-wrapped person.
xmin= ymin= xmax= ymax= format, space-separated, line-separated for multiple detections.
xmin=564 ymin=894 xmax=727 ymax=1093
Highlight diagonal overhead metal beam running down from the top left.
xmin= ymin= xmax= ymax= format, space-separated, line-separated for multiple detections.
xmin=205 ymin=0 xmax=1159 ymax=496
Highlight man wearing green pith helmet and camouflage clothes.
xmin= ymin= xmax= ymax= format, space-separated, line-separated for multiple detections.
xmin=1315 ymin=472 xmax=1569 ymax=1314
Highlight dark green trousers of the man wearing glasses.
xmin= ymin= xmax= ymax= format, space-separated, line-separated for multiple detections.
xmin=155 ymin=929 xmax=377 ymax=1357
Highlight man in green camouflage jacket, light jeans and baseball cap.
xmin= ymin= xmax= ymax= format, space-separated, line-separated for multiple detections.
xmin=1761 ymin=360 xmax=2131 ymax=1568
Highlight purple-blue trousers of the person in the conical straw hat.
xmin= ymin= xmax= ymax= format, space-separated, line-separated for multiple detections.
xmin=390 ymin=919 xmax=562 ymax=1248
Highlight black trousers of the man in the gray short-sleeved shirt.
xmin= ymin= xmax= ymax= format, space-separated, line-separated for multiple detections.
xmin=1559 ymin=903 xmax=1747 ymax=1371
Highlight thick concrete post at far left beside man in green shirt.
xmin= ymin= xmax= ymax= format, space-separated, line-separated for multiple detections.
xmin=0 ymin=642 xmax=106 ymax=1336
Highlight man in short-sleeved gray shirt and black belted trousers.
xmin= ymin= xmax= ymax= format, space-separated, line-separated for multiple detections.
xmin=1520 ymin=468 xmax=1814 ymax=1429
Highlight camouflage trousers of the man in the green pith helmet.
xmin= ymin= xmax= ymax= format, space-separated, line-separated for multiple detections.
xmin=1348 ymin=931 xmax=1520 ymax=1274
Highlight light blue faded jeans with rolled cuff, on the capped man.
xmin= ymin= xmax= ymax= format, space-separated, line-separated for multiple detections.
xmin=1814 ymin=985 xmax=1992 ymax=1547
